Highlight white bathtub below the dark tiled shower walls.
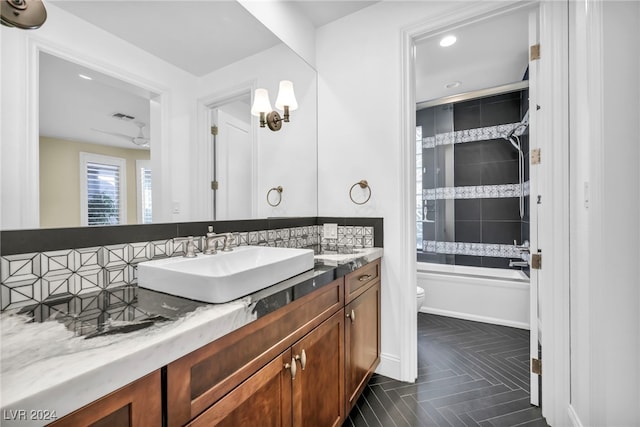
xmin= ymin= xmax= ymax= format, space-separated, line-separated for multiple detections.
xmin=417 ymin=262 xmax=529 ymax=329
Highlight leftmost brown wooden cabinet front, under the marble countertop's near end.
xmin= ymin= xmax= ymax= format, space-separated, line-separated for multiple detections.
xmin=49 ymin=371 xmax=162 ymax=427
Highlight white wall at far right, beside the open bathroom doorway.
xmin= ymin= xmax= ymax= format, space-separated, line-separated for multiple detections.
xmin=570 ymin=0 xmax=640 ymax=426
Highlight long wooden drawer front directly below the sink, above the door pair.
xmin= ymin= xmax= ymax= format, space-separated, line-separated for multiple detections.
xmin=167 ymin=279 xmax=344 ymax=426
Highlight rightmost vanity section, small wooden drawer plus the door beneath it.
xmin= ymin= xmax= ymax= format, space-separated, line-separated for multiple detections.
xmin=344 ymin=260 xmax=380 ymax=414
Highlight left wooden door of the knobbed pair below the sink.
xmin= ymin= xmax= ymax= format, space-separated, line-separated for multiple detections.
xmin=187 ymin=349 xmax=296 ymax=427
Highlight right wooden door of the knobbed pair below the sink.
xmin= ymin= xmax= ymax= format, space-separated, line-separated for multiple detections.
xmin=291 ymin=310 xmax=345 ymax=427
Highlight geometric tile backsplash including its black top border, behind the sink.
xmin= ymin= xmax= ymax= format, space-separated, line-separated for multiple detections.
xmin=0 ymin=217 xmax=383 ymax=311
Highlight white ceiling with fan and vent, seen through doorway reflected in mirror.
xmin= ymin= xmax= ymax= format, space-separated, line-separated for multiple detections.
xmin=39 ymin=52 xmax=155 ymax=149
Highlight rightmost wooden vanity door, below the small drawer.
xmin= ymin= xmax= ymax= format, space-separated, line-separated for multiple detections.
xmin=345 ymin=281 xmax=380 ymax=413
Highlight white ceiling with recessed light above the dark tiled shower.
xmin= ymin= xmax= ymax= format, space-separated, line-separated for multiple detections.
xmin=416 ymin=8 xmax=529 ymax=102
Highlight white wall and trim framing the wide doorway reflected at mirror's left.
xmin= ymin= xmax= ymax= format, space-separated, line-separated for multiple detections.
xmin=0 ymin=4 xmax=196 ymax=229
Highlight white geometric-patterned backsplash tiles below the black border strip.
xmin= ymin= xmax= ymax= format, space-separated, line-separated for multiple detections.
xmin=0 ymin=225 xmax=374 ymax=311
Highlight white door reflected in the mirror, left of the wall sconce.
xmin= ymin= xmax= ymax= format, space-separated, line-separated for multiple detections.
xmin=213 ymin=109 xmax=254 ymax=220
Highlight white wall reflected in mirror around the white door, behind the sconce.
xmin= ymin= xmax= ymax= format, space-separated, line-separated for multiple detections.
xmin=194 ymin=44 xmax=317 ymax=218
